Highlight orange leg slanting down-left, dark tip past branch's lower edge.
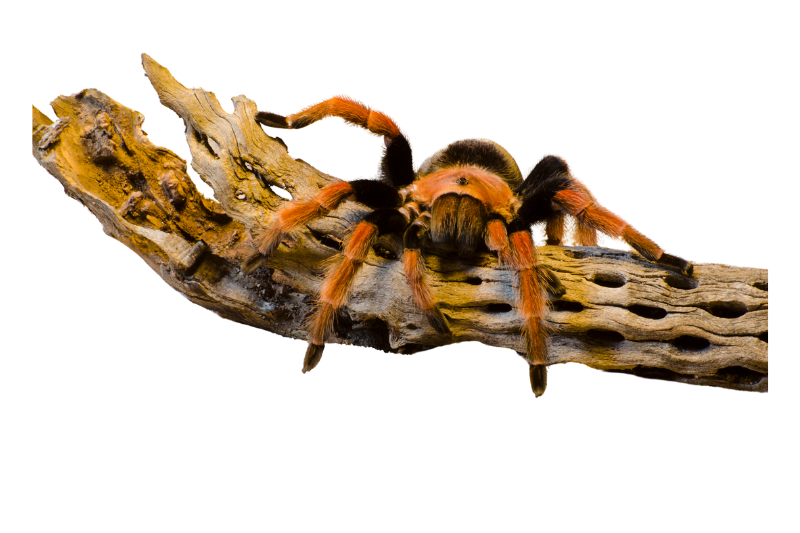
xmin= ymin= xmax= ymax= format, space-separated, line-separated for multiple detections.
xmin=302 ymin=221 xmax=378 ymax=374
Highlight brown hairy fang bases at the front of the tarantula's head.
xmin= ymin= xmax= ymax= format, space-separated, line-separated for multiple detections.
xmin=431 ymin=193 xmax=489 ymax=255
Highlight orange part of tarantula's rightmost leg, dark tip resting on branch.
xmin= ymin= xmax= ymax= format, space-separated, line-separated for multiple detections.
xmin=553 ymin=189 xmax=692 ymax=275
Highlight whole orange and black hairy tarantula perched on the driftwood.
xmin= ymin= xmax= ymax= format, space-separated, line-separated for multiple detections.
xmin=244 ymin=94 xmax=692 ymax=397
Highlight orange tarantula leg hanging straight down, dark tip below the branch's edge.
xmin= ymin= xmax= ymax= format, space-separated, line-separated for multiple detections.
xmin=486 ymin=219 xmax=547 ymax=398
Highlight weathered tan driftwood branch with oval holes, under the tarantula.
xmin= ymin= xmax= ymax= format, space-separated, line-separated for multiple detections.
xmin=32 ymin=53 xmax=769 ymax=392
